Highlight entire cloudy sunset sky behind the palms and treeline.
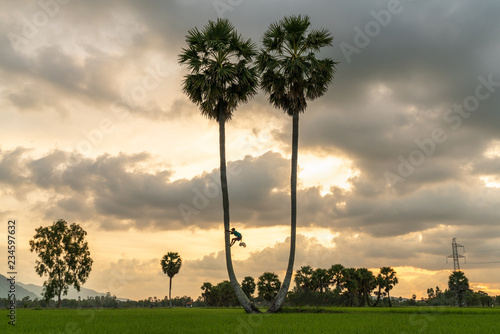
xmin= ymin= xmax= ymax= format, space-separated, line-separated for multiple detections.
xmin=0 ymin=0 xmax=500 ymax=299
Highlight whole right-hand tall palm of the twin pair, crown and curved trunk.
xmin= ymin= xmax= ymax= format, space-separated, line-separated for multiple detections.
xmin=257 ymin=15 xmax=336 ymax=312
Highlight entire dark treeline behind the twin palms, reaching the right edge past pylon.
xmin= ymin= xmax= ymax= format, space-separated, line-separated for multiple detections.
xmin=194 ymin=264 xmax=500 ymax=307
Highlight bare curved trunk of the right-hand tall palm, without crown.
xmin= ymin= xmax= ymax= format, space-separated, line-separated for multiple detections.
xmin=268 ymin=113 xmax=299 ymax=313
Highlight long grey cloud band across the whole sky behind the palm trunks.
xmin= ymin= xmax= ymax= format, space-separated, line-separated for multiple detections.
xmin=0 ymin=148 xmax=500 ymax=243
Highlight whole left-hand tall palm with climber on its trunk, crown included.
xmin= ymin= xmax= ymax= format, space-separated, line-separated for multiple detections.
xmin=179 ymin=19 xmax=259 ymax=313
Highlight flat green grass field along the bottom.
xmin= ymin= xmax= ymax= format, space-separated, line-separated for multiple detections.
xmin=0 ymin=307 xmax=500 ymax=334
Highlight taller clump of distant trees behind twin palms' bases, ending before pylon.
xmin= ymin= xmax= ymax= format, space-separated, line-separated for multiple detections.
xmin=196 ymin=264 xmax=398 ymax=306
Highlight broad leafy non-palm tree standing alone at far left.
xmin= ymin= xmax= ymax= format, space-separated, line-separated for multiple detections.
xmin=29 ymin=219 xmax=94 ymax=308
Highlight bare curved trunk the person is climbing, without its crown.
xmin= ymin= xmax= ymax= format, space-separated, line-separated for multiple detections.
xmin=219 ymin=103 xmax=260 ymax=313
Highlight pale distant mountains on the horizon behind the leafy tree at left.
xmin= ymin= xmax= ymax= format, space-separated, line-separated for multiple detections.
xmin=0 ymin=274 xmax=127 ymax=300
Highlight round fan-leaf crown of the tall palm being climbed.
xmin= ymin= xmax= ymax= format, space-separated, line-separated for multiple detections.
xmin=179 ymin=19 xmax=258 ymax=121
